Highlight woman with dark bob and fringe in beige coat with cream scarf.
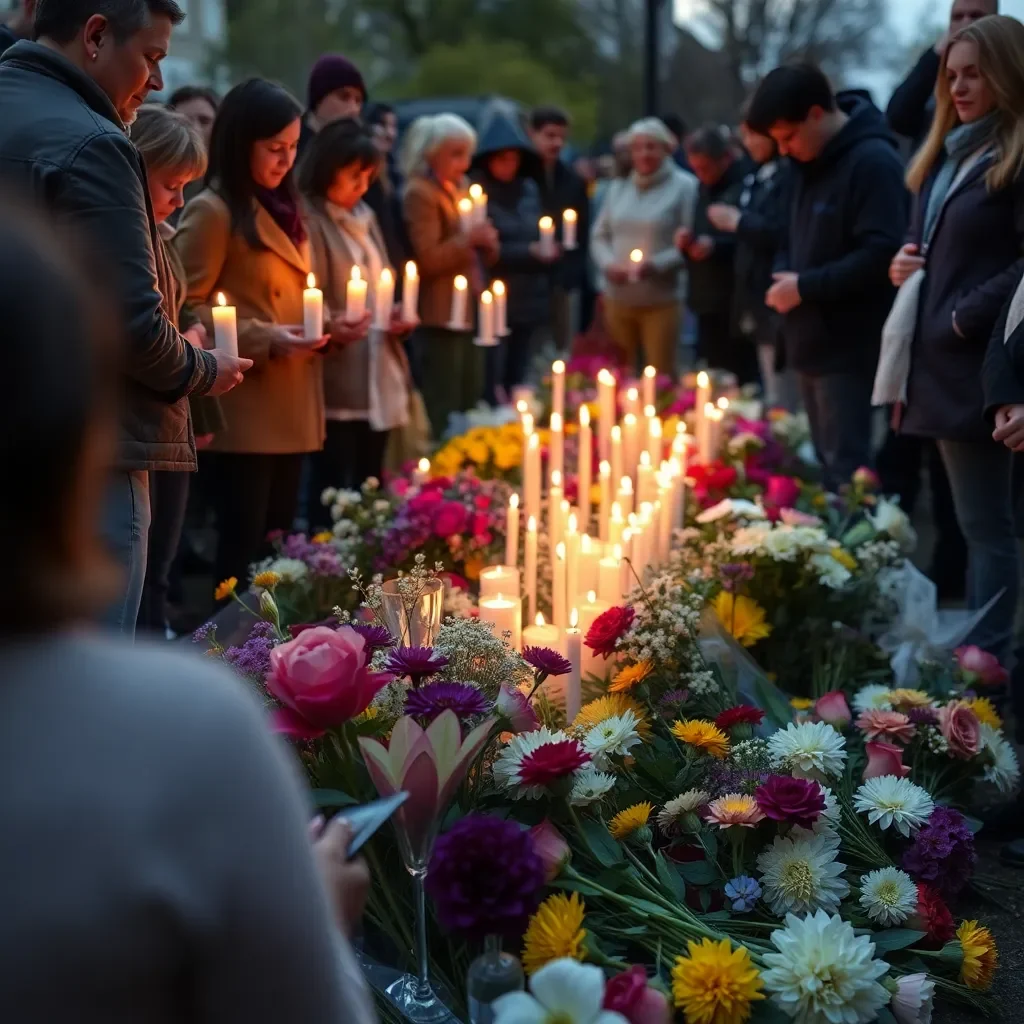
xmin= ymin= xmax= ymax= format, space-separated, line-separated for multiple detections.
xmin=299 ymin=120 xmax=412 ymax=515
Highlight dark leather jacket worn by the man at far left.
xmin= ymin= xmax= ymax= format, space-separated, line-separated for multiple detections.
xmin=0 ymin=42 xmax=217 ymax=470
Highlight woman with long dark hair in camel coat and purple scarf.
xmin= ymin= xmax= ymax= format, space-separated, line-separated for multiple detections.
xmin=174 ymin=79 xmax=328 ymax=598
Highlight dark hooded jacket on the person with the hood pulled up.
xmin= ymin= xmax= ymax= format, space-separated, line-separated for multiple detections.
xmin=470 ymin=114 xmax=551 ymax=328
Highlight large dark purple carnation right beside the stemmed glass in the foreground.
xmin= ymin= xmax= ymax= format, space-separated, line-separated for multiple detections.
xmin=427 ymin=814 xmax=545 ymax=941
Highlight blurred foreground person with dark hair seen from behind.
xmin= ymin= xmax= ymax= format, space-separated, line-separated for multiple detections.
xmin=0 ymin=195 xmax=373 ymax=1024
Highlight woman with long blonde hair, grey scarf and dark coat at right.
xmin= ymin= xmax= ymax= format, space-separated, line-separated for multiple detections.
xmin=890 ymin=16 xmax=1024 ymax=659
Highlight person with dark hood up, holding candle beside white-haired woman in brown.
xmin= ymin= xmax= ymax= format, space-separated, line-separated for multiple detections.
xmin=470 ymin=114 xmax=559 ymax=404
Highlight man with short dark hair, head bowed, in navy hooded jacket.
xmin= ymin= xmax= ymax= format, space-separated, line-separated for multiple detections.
xmin=746 ymin=63 xmax=908 ymax=490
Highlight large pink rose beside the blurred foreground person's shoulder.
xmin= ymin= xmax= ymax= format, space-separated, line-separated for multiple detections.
xmin=266 ymin=626 xmax=392 ymax=739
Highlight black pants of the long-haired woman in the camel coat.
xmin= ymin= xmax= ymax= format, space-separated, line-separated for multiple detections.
xmin=207 ymin=452 xmax=303 ymax=585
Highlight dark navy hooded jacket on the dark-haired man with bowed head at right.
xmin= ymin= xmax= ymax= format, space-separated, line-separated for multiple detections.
xmin=777 ymin=91 xmax=909 ymax=375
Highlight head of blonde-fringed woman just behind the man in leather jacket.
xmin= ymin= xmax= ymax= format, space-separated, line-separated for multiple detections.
xmin=131 ymin=103 xmax=207 ymax=224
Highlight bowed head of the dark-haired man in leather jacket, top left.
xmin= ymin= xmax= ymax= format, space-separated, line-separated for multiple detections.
xmin=33 ymin=0 xmax=185 ymax=125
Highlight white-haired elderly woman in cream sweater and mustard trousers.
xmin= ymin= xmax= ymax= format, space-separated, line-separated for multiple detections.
xmin=591 ymin=118 xmax=699 ymax=375
